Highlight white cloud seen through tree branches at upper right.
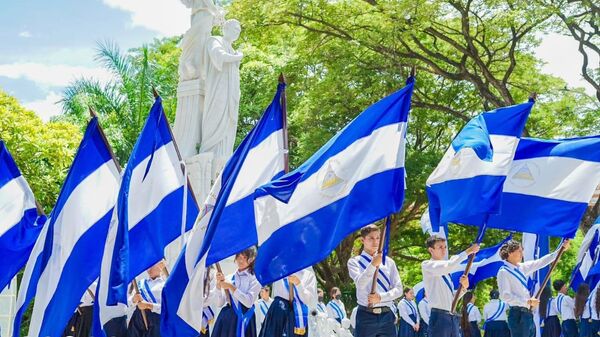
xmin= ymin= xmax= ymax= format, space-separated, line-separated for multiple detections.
xmin=535 ymin=33 xmax=600 ymax=95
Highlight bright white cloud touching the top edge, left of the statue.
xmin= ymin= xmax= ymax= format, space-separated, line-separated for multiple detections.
xmin=102 ymin=0 xmax=190 ymax=36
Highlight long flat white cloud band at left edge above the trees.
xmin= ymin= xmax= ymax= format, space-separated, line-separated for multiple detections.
xmin=0 ymin=62 xmax=112 ymax=88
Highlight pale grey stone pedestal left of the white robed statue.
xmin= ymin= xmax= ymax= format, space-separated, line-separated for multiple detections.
xmin=173 ymin=79 xmax=204 ymax=158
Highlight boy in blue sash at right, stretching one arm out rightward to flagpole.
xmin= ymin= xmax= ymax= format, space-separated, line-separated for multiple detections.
xmin=497 ymin=240 xmax=570 ymax=337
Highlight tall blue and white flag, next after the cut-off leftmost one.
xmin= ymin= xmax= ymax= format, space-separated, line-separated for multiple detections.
xmin=29 ymin=118 xmax=120 ymax=337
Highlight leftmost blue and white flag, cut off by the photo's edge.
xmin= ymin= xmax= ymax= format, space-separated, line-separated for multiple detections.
xmin=0 ymin=140 xmax=46 ymax=292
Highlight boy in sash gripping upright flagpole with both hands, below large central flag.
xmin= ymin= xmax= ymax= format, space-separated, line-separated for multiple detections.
xmin=348 ymin=225 xmax=402 ymax=337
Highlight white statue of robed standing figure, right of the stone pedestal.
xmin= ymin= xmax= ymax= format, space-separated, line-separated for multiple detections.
xmin=200 ymin=20 xmax=243 ymax=160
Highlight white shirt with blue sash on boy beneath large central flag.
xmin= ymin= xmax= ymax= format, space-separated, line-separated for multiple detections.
xmin=348 ymin=251 xmax=402 ymax=311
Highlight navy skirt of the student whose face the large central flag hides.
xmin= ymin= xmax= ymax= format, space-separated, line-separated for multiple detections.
xmin=260 ymin=296 xmax=309 ymax=337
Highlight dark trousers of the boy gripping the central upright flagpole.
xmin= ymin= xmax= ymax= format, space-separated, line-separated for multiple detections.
xmin=355 ymin=307 xmax=396 ymax=337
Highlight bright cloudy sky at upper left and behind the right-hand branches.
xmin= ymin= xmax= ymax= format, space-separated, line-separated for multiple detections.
xmin=0 ymin=0 xmax=591 ymax=120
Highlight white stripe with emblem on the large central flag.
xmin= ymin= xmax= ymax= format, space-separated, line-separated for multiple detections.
xmin=254 ymin=122 xmax=406 ymax=244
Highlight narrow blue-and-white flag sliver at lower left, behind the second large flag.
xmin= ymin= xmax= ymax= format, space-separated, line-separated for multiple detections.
xmin=11 ymin=220 xmax=48 ymax=337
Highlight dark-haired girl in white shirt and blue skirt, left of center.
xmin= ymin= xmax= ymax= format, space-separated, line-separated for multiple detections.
xmin=212 ymin=247 xmax=261 ymax=337
